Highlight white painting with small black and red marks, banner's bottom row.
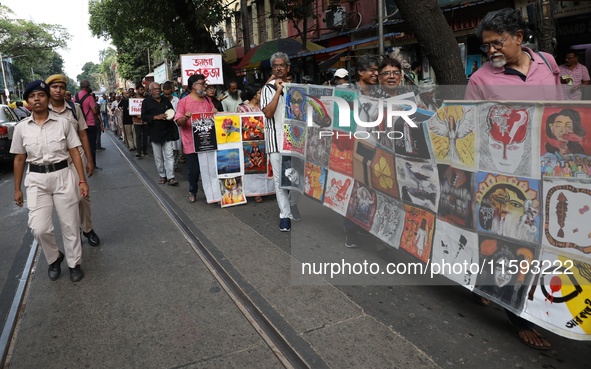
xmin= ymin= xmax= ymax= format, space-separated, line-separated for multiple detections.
xmin=431 ymin=221 xmax=480 ymax=290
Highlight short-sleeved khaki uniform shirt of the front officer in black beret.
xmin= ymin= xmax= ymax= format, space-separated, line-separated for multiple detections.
xmin=10 ymin=113 xmax=82 ymax=165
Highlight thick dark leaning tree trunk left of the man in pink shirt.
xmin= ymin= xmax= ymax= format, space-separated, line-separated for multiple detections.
xmin=396 ymin=0 xmax=466 ymax=85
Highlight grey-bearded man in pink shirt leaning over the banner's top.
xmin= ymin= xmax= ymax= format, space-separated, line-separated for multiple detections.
xmin=465 ymin=8 xmax=563 ymax=100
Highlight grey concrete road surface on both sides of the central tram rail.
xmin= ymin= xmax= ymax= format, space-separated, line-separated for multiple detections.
xmin=8 ymin=132 xmax=438 ymax=369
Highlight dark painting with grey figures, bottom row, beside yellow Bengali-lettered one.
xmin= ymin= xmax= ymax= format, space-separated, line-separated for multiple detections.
xmin=475 ymin=235 xmax=537 ymax=312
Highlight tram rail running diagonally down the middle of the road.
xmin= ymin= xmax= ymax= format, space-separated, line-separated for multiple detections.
xmin=108 ymin=135 xmax=329 ymax=369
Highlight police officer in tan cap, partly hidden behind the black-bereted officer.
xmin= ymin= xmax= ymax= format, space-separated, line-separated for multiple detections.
xmin=45 ymin=74 xmax=101 ymax=246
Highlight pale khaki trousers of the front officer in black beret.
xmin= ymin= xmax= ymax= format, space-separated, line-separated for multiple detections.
xmin=25 ymin=166 xmax=82 ymax=268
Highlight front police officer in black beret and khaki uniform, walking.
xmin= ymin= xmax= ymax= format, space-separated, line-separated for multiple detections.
xmin=10 ymin=81 xmax=89 ymax=282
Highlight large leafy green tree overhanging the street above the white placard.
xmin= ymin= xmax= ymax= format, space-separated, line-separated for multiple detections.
xmin=89 ymin=0 xmax=234 ymax=82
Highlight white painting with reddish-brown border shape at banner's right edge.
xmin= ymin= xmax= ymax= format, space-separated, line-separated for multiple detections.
xmin=542 ymin=178 xmax=591 ymax=256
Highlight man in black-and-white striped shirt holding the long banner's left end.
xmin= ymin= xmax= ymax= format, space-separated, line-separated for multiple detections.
xmin=261 ymin=52 xmax=300 ymax=232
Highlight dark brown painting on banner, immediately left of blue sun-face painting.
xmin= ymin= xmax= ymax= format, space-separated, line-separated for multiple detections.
xmin=437 ymin=164 xmax=474 ymax=229
